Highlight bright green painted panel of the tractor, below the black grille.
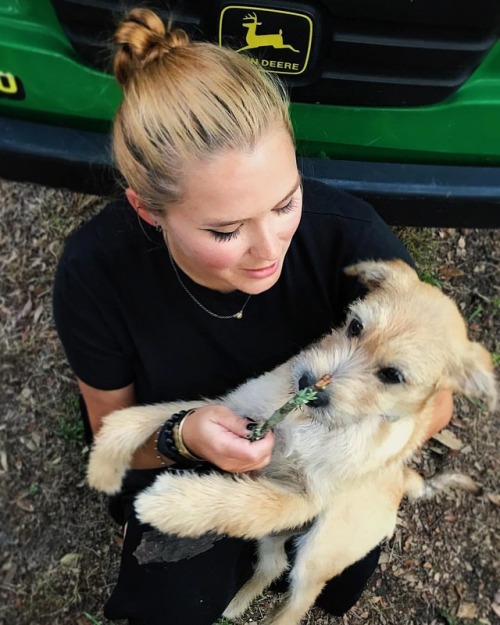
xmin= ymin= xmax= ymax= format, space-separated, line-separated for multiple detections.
xmin=0 ymin=0 xmax=500 ymax=165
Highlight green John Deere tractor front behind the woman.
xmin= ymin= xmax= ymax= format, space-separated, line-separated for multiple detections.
xmin=0 ymin=0 xmax=500 ymax=227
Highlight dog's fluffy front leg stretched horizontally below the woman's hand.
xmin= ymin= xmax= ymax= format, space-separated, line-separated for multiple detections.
xmin=135 ymin=473 xmax=321 ymax=538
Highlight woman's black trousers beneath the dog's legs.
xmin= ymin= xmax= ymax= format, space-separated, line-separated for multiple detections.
xmin=104 ymin=471 xmax=379 ymax=625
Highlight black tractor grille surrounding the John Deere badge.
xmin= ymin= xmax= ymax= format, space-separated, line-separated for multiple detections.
xmin=53 ymin=0 xmax=500 ymax=106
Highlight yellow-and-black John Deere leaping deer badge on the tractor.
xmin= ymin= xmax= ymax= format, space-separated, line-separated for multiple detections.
xmin=219 ymin=6 xmax=313 ymax=74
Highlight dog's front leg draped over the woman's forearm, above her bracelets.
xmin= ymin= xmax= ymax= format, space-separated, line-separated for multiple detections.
xmin=87 ymin=402 xmax=200 ymax=495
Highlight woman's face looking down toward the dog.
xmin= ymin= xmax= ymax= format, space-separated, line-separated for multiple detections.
xmin=161 ymin=129 xmax=302 ymax=294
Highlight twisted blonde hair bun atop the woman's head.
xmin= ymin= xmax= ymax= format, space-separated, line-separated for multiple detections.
xmin=113 ymin=8 xmax=190 ymax=86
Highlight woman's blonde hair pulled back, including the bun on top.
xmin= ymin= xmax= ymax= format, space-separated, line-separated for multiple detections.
xmin=113 ymin=8 xmax=293 ymax=211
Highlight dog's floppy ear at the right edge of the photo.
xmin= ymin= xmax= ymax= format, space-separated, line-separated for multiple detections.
xmin=448 ymin=341 xmax=498 ymax=411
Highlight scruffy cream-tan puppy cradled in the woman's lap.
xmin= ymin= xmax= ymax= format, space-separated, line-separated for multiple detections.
xmin=88 ymin=261 xmax=496 ymax=625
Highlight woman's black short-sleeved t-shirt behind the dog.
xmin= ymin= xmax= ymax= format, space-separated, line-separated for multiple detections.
xmin=54 ymin=180 xmax=411 ymax=403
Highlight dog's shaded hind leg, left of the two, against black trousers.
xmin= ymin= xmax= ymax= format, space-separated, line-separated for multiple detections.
xmin=223 ymin=535 xmax=288 ymax=619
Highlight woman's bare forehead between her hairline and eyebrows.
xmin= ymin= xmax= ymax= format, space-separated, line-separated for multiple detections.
xmin=175 ymin=129 xmax=298 ymax=222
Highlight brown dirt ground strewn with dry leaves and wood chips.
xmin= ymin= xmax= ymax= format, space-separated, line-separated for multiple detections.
xmin=0 ymin=181 xmax=500 ymax=625
